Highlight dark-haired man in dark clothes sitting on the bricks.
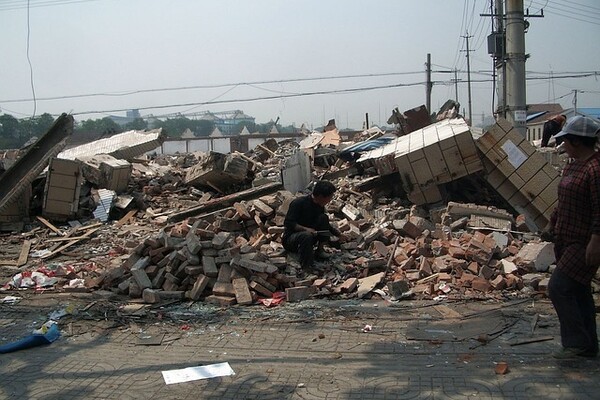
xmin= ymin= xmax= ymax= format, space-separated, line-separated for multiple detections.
xmin=282 ymin=181 xmax=345 ymax=268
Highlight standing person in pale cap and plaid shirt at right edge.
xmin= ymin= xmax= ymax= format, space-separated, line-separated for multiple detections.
xmin=548 ymin=116 xmax=600 ymax=359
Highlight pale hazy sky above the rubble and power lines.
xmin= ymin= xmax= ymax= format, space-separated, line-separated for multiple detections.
xmin=0 ymin=0 xmax=600 ymax=129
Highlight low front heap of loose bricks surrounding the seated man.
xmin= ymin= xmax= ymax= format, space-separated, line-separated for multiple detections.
xmin=90 ymin=191 xmax=553 ymax=305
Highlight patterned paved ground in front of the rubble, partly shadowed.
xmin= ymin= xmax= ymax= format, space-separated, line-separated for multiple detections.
xmin=0 ymin=301 xmax=600 ymax=400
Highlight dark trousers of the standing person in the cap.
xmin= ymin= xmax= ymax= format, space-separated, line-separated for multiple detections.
xmin=548 ymin=269 xmax=598 ymax=353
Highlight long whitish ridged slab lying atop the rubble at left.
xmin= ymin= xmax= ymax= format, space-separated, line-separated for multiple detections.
xmin=58 ymin=129 xmax=165 ymax=161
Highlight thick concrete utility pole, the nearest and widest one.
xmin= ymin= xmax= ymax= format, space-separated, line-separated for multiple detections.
xmin=506 ymin=0 xmax=527 ymax=137
